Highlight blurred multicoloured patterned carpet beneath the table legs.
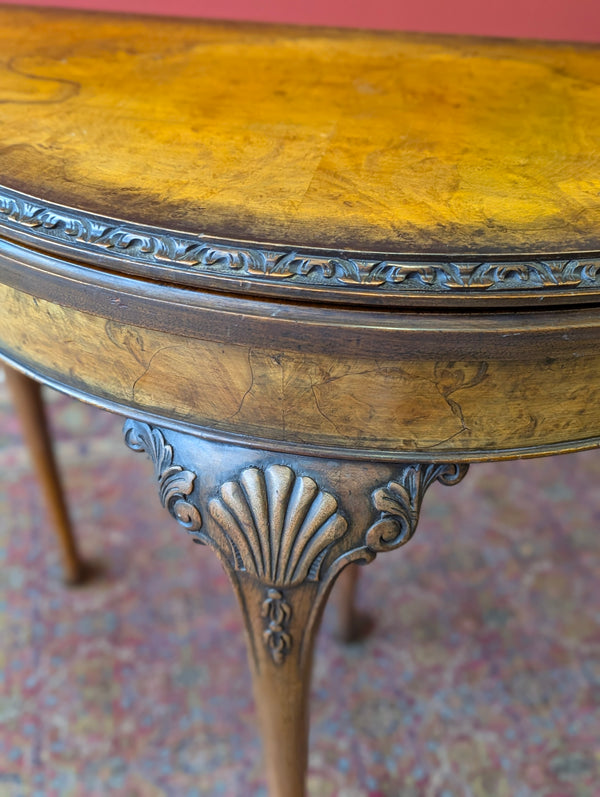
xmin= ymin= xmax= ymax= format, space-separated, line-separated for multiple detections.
xmin=0 ymin=370 xmax=600 ymax=797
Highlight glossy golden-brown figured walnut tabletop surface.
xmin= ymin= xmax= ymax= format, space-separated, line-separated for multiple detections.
xmin=0 ymin=7 xmax=600 ymax=255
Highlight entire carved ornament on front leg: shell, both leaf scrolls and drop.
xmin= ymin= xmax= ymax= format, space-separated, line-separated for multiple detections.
xmin=123 ymin=420 xmax=469 ymax=664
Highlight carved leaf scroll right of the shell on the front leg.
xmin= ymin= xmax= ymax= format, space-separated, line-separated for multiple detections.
xmin=365 ymin=464 xmax=469 ymax=553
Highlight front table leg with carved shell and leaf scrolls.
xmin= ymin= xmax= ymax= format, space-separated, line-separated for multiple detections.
xmin=125 ymin=421 xmax=468 ymax=797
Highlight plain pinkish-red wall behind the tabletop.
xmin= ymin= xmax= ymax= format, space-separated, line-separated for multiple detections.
xmin=3 ymin=0 xmax=600 ymax=42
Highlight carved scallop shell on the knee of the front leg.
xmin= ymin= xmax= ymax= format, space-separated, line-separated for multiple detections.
xmin=209 ymin=465 xmax=348 ymax=587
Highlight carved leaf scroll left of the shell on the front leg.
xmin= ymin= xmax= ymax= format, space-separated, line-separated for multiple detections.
xmin=123 ymin=420 xmax=202 ymax=531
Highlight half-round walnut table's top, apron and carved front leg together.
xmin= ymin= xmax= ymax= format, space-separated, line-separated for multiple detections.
xmin=0 ymin=8 xmax=600 ymax=797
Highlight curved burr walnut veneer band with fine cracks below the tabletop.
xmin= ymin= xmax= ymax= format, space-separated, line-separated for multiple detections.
xmin=0 ymin=286 xmax=600 ymax=460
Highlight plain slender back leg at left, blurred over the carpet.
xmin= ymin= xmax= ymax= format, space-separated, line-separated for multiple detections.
xmin=5 ymin=366 xmax=86 ymax=584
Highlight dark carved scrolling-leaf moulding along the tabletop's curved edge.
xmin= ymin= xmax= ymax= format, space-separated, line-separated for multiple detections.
xmin=0 ymin=189 xmax=600 ymax=294
